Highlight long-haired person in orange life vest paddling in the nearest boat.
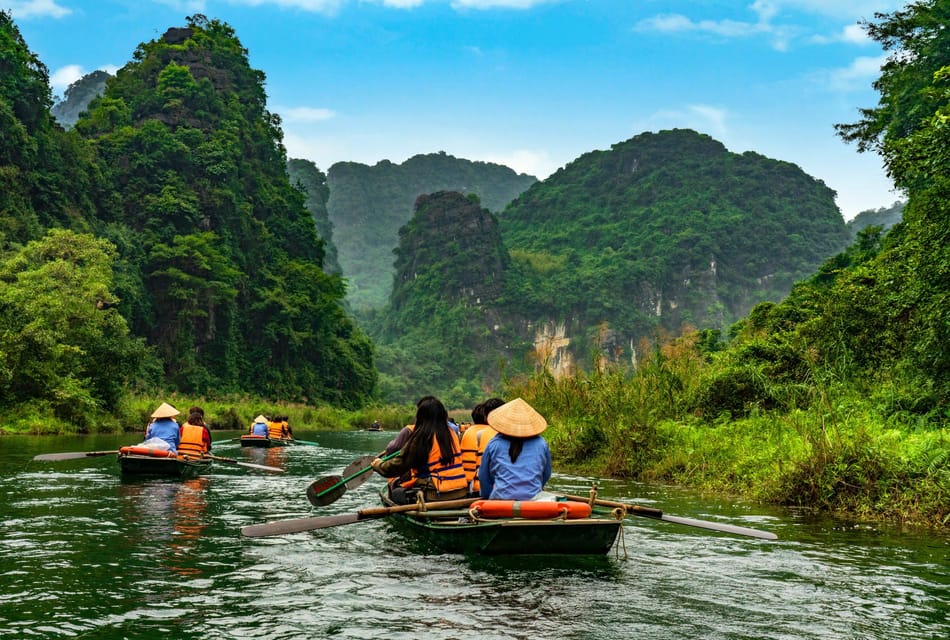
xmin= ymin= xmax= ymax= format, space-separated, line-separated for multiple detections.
xmin=372 ymin=396 xmax=468 ymax=504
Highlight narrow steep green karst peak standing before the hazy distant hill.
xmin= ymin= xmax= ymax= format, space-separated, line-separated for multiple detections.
xmin=371 ymin=191 xmax=527 ymax=407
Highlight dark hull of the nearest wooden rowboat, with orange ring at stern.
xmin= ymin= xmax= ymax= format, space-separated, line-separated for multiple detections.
xmin=381 ymin=493 xmax=622 ymax=555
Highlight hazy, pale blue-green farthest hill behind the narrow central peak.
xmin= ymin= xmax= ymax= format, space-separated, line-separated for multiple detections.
xmin=327 ymin=152 xmax=537 ymax=308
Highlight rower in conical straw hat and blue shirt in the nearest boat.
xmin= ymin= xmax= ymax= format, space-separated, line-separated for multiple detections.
xmin=478 ymin=398 xmax=551 ymax=500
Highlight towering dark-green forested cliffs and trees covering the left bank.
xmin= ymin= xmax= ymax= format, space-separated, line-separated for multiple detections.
xmin=0 ymin=13 xmax=376 ymax=427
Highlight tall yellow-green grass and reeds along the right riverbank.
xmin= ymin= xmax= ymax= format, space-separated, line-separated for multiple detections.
xmin=508 ymin=336 xmax=950 ymax=526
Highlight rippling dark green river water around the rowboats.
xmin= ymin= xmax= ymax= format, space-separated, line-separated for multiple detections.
xmin=0 ymin=432 xmax=950 ymax=640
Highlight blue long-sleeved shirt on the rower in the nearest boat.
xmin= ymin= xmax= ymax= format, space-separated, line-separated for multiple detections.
xmin=478 ymin=433 xmax=551 ymax=500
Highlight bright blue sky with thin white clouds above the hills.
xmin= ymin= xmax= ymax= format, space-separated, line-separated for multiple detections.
xmin=9 ymin=0 xmax=905 ymax=219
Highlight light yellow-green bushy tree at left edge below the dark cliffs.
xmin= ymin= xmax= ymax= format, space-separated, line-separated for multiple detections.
xmin=0 ymin=229 xmax=148 ymax=428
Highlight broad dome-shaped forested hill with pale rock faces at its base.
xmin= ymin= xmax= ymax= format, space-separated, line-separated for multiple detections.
xmin=500 ymin=130 xmax=849 ymax=356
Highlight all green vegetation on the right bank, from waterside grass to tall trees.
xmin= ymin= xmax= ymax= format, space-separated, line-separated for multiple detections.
xmin=508 ymin=0 xmax=950 ymax=526
